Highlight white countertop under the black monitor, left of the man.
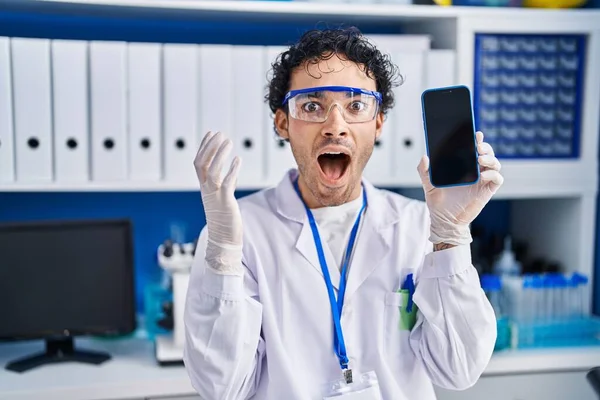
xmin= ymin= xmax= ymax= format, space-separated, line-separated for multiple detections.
xmin=0 ymin=338 xmax=195 ymax=400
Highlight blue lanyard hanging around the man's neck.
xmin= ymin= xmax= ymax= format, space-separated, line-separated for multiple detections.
xmin=294 ymin=179 xmax=367 ymax=383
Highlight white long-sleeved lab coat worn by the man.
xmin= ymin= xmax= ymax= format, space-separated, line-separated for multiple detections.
xmin=184 ymin=170 xmax=496 ymax=400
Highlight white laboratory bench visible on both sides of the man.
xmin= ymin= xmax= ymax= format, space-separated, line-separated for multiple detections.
xmin=0 ymin=337 xmax=600 ymax=400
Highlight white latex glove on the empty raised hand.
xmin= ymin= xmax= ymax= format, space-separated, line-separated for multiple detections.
xmin=194 ymin=132 xmax=243 ymax=274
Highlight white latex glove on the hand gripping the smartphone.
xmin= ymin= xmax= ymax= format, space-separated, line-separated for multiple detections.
xmin=417 ymin=132 xmax=504 ymax=246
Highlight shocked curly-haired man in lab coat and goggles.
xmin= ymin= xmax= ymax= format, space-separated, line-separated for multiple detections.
xmin=184 ymin=29 xmax=503 ymax=400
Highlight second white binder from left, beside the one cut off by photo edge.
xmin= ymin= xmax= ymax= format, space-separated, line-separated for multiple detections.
xmin=11 ymin=38 xmax=54 ymax=182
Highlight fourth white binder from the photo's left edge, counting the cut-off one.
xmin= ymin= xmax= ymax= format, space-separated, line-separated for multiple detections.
xmin=90 ymin=41 xmax=128 ymax=182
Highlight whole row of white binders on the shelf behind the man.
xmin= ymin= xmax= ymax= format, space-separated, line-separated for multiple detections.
xmin=0 ymin=35 xmax=455 ymax=186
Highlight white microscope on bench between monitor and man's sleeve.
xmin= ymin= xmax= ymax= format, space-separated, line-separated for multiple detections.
xmin=155 ymin=240 xmax=196 ymax=365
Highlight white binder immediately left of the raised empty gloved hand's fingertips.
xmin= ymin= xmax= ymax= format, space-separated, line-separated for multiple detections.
xmin=163 ymin=44 xmax=200 ymax=184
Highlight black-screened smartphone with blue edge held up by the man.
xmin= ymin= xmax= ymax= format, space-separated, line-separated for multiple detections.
xmin=421 ymin=86 xmax=479 ymax=188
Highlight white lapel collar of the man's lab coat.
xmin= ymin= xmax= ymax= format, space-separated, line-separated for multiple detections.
xmin=275 ymin=169 xmax=399 ymax=296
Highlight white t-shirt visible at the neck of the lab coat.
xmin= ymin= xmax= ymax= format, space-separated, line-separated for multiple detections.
xmin=311 ymin=192 xmax=363 ymax=270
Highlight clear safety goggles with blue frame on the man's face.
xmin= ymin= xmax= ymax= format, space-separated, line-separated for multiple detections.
xmin=282 ymin=86 xmax=382 ymax=124
